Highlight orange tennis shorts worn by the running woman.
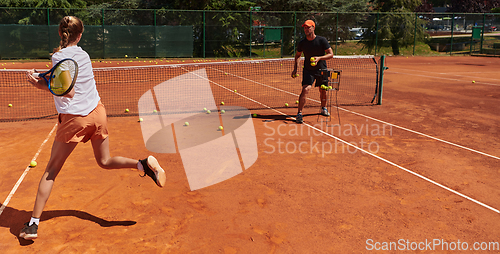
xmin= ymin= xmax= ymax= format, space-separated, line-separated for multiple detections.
xmin=56 ymin=102 xmax=108 ymax=143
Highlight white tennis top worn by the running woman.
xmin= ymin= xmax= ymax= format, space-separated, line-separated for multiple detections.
xmin=52 ymin=46 xmax=101 ymax=116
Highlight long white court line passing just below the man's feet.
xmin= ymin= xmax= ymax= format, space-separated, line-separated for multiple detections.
xmin=188 ymin=66 xmax=500 ymax=213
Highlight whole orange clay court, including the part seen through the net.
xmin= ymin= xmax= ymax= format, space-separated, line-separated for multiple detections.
xmin=0 ymin=56 xmax=500 ymax=253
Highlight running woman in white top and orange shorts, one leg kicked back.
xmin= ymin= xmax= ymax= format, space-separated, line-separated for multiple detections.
xmin=19 ymin=16 xmax=166 ymax=240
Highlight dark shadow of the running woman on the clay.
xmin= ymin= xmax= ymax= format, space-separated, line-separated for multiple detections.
xmin=0 ymin=203 xmax=137 ymax=246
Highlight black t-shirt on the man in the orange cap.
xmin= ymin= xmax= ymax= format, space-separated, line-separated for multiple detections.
xmin=297 ymin=35 xmax=330 ymax=70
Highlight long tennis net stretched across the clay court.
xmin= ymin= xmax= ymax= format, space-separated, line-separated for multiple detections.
xmin=0 ymin=56 xmax=380 ymax=121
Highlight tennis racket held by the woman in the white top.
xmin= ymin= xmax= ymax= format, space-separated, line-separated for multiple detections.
xmin=33 ymin=58 xmax=78 ymax=96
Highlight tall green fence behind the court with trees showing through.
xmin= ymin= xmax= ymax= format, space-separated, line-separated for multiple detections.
xmin=0 ymin=8 xmax=500 ymax=59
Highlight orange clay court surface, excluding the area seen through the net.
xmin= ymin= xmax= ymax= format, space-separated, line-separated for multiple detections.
xmin=0 ymin=57 xmax=500 ymax=253
